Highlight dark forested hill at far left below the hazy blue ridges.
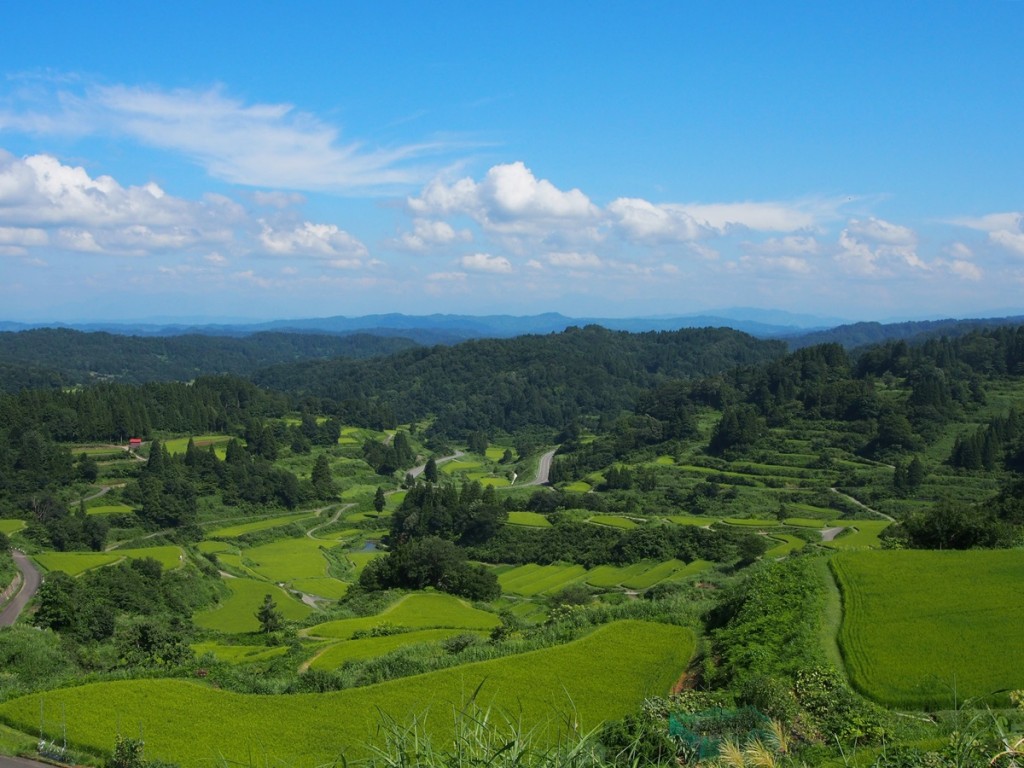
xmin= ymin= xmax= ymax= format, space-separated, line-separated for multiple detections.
xmin=0 ymin=329 xmax=416 ymax=391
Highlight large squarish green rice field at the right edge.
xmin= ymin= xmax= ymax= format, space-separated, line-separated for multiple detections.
xmin=831 ymin=550 xmax=1024 ymax=709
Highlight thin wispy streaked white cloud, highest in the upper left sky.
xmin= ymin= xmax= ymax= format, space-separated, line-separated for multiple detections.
xmin=0 ymin=83 xmax=454 ymax=193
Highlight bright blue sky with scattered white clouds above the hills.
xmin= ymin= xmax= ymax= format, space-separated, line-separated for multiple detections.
xmin=0 ymin=0 xmax=1024 ymax=322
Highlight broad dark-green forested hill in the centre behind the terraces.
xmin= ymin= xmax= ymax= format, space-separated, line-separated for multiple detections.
xmin=254 ymin=326 xmax=785 ymax=436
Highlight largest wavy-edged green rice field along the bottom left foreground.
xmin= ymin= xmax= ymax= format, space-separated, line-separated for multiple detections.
xmin=0 ymin=622 xmax=695 ymax=768
